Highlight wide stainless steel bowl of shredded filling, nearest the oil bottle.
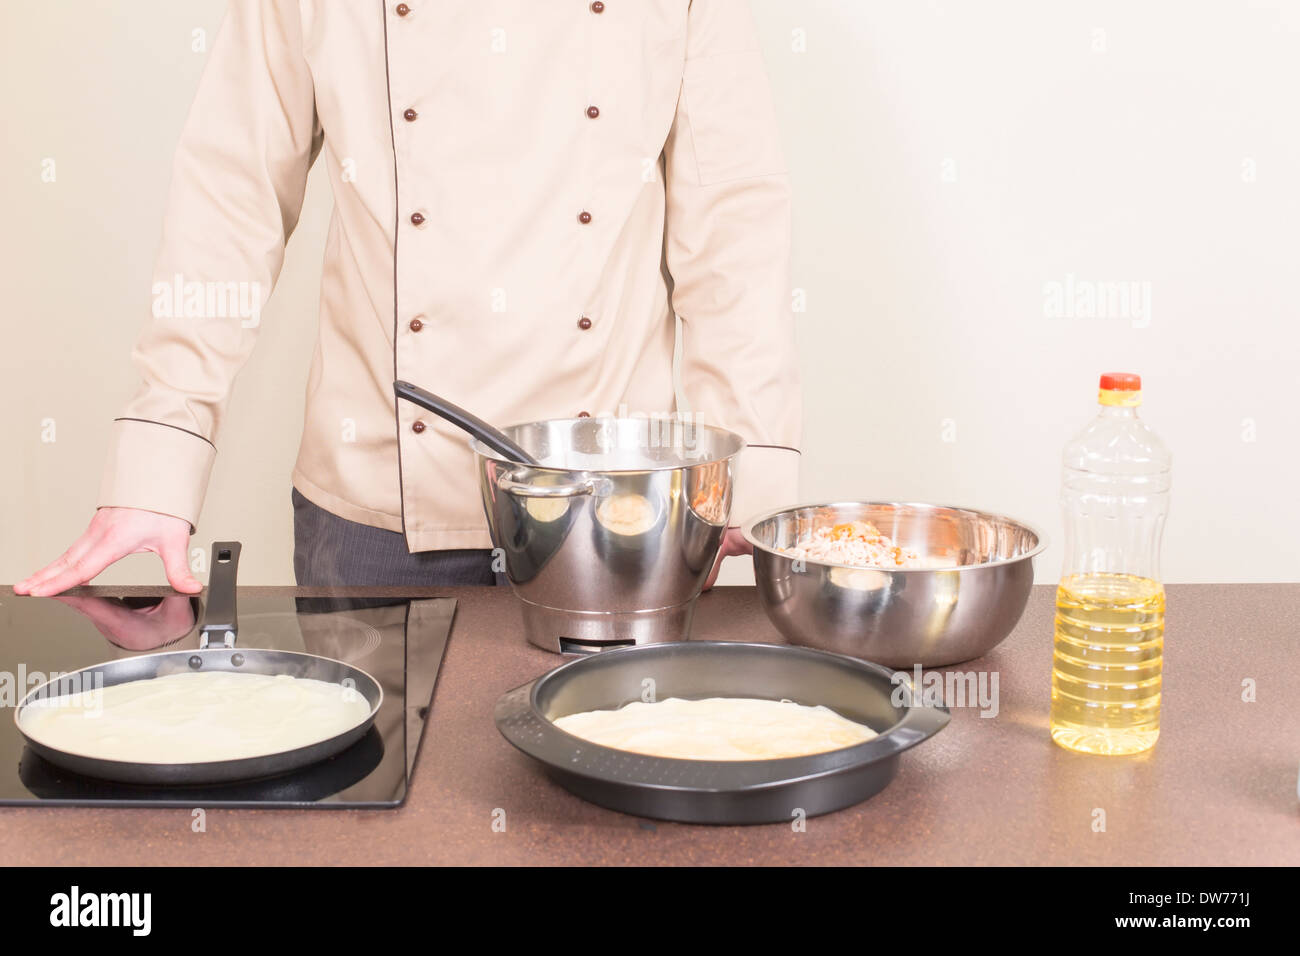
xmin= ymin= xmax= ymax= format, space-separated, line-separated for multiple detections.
xmin=745 ymin=502 xmax=1047 ymax=667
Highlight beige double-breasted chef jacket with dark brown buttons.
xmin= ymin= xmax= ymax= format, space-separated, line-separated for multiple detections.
xmin=99 ymin=0 xmax=801 ymax=551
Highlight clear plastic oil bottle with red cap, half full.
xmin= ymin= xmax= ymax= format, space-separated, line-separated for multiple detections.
xmin=1050 ymin=372 xmax=1170 ymax=754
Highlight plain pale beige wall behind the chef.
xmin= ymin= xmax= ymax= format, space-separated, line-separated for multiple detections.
xmin=0 ymin=0 xmax=1300 ymax=583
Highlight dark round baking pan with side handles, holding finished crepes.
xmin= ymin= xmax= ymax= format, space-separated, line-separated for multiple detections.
xmin=497 ymin=641 xmax=950 ymax=823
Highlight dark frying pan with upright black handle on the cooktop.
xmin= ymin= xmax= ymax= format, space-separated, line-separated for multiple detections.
xmin=13 ymin=541 xmax=384 ymax=786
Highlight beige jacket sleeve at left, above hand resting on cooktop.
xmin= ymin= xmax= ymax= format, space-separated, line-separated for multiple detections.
xmin=99 ymin=0 xmax=321 ymax=528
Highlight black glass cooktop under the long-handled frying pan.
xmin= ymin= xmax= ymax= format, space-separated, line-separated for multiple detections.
xmin=0 ymin=588 xmax=456 ymax=808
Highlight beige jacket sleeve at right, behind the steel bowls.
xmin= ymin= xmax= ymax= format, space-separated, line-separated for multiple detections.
xmin=664 ymin=0 xmax=802 ymax=524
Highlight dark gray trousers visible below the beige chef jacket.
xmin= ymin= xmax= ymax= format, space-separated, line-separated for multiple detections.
xmin=293 ymin=488 xmax=504 ymax=588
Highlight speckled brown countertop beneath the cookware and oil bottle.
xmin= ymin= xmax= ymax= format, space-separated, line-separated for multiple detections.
xmin=0 ymin=584 xmax=1300 ymax=866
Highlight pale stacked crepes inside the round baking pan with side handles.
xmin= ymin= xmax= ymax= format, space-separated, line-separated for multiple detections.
xmin=554 ymin=697 xmax=876 ymax=761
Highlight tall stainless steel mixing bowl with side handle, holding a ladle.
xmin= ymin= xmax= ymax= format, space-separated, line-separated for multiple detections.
xmin=471 ymin=418 xmax=745 ymax=653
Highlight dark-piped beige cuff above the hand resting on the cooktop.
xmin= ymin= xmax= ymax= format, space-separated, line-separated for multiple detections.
xmin=96 ymin=419 xmax=217 ymax=533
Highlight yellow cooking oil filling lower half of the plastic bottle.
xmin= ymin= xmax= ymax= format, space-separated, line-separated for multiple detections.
xmin=1052 ymin=572 xmax=1165 ymax=754
